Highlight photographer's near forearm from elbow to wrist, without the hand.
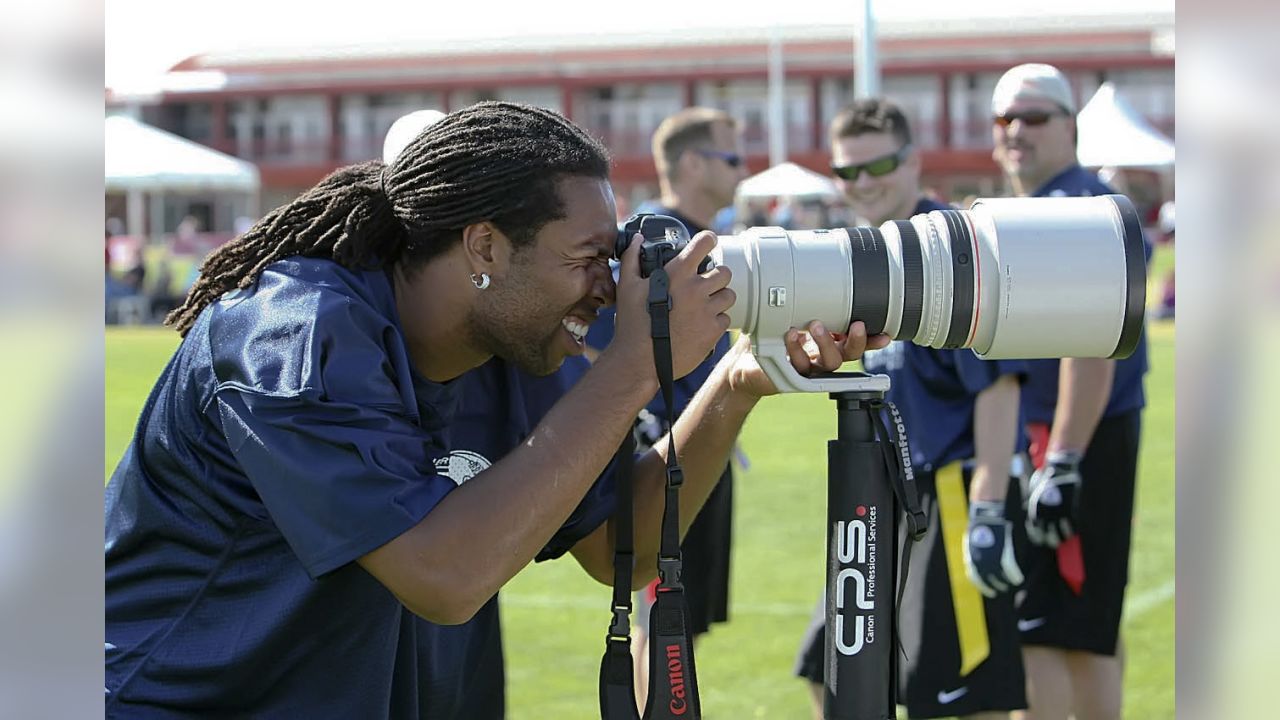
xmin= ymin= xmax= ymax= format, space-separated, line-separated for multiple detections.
xmin=361 ymin=357 xmax=654 ymax=623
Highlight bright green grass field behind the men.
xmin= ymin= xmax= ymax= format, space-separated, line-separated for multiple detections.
xmin=106 ymin=289 xmax=1174 ymax=720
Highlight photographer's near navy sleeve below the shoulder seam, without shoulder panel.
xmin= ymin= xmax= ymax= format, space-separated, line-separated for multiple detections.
xmin=216 ymin=389 xmax=457 ymax=578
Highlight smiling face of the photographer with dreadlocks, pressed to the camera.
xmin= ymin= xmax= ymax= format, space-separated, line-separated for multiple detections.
xmin=466 ymin=177 xmax=617 ymax=375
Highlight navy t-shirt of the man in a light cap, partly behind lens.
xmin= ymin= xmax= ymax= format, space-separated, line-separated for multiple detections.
xmin=1023 ymin=165 xmax=1151 ymax=423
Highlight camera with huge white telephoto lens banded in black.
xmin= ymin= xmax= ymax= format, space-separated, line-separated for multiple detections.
xmin=616 ymin=195 xmax=1147 ymax=392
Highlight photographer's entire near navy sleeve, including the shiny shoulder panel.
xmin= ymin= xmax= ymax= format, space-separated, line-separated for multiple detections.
xmin=209 ymin=273 xmax=457 ymax=578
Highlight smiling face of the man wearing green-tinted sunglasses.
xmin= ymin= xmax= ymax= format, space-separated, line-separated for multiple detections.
xmin=831 ymin=132 xmax=920 ymax=225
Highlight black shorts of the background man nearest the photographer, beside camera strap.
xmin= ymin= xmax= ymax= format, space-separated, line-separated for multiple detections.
xmin=634 ymin=458 xmax=733 ymax=635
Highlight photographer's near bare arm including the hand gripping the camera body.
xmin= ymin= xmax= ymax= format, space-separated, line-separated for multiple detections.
xmin=358 ymin=233 xmax=733 ymax=624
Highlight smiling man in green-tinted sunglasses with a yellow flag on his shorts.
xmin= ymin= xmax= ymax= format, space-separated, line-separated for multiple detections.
xmin=796 ymin=99 xmax=1027 ymax=719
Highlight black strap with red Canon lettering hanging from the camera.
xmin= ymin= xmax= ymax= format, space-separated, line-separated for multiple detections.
xmin=600 ymin=266 xmax=701 ymax=720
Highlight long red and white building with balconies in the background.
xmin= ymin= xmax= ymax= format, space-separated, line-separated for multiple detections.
xmin=108 ymin=14 xmax=1174 ymax=219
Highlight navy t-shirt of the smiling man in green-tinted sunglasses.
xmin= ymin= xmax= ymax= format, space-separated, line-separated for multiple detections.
xmin=863 ymin=199 xmax=1027 ymax=470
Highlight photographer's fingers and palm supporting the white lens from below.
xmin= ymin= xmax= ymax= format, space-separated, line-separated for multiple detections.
xmin=730 ymin=320 xmax=890 ymax=397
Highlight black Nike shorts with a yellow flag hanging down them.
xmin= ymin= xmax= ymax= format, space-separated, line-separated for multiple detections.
xmin=796 ymin=462 xmax=1027 ymax=719
